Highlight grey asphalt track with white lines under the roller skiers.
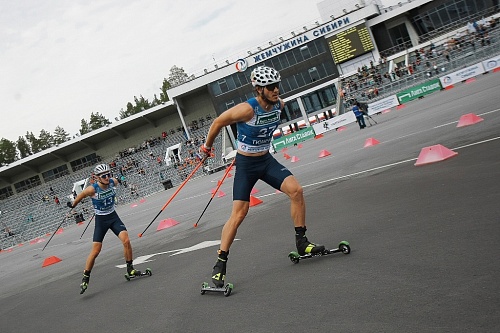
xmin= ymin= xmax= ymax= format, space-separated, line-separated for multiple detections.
xmin=0 ymin=73 xmax=500 ymax=333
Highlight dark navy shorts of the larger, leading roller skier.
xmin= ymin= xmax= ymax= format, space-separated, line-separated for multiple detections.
xmin=233 ymin=153 xmax=292 ymax=201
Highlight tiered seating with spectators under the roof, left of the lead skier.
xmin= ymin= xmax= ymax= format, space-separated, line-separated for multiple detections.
xmin=0 ymin=116 xmax=222 ymax=249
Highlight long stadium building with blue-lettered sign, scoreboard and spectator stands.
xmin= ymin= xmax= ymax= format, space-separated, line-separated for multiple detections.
xmin=0 ymin=0 xmax=500 ymax=246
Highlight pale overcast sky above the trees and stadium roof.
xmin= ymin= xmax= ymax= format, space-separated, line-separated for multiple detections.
xmin=0 ymin=0 xmax=320 ymax=141
